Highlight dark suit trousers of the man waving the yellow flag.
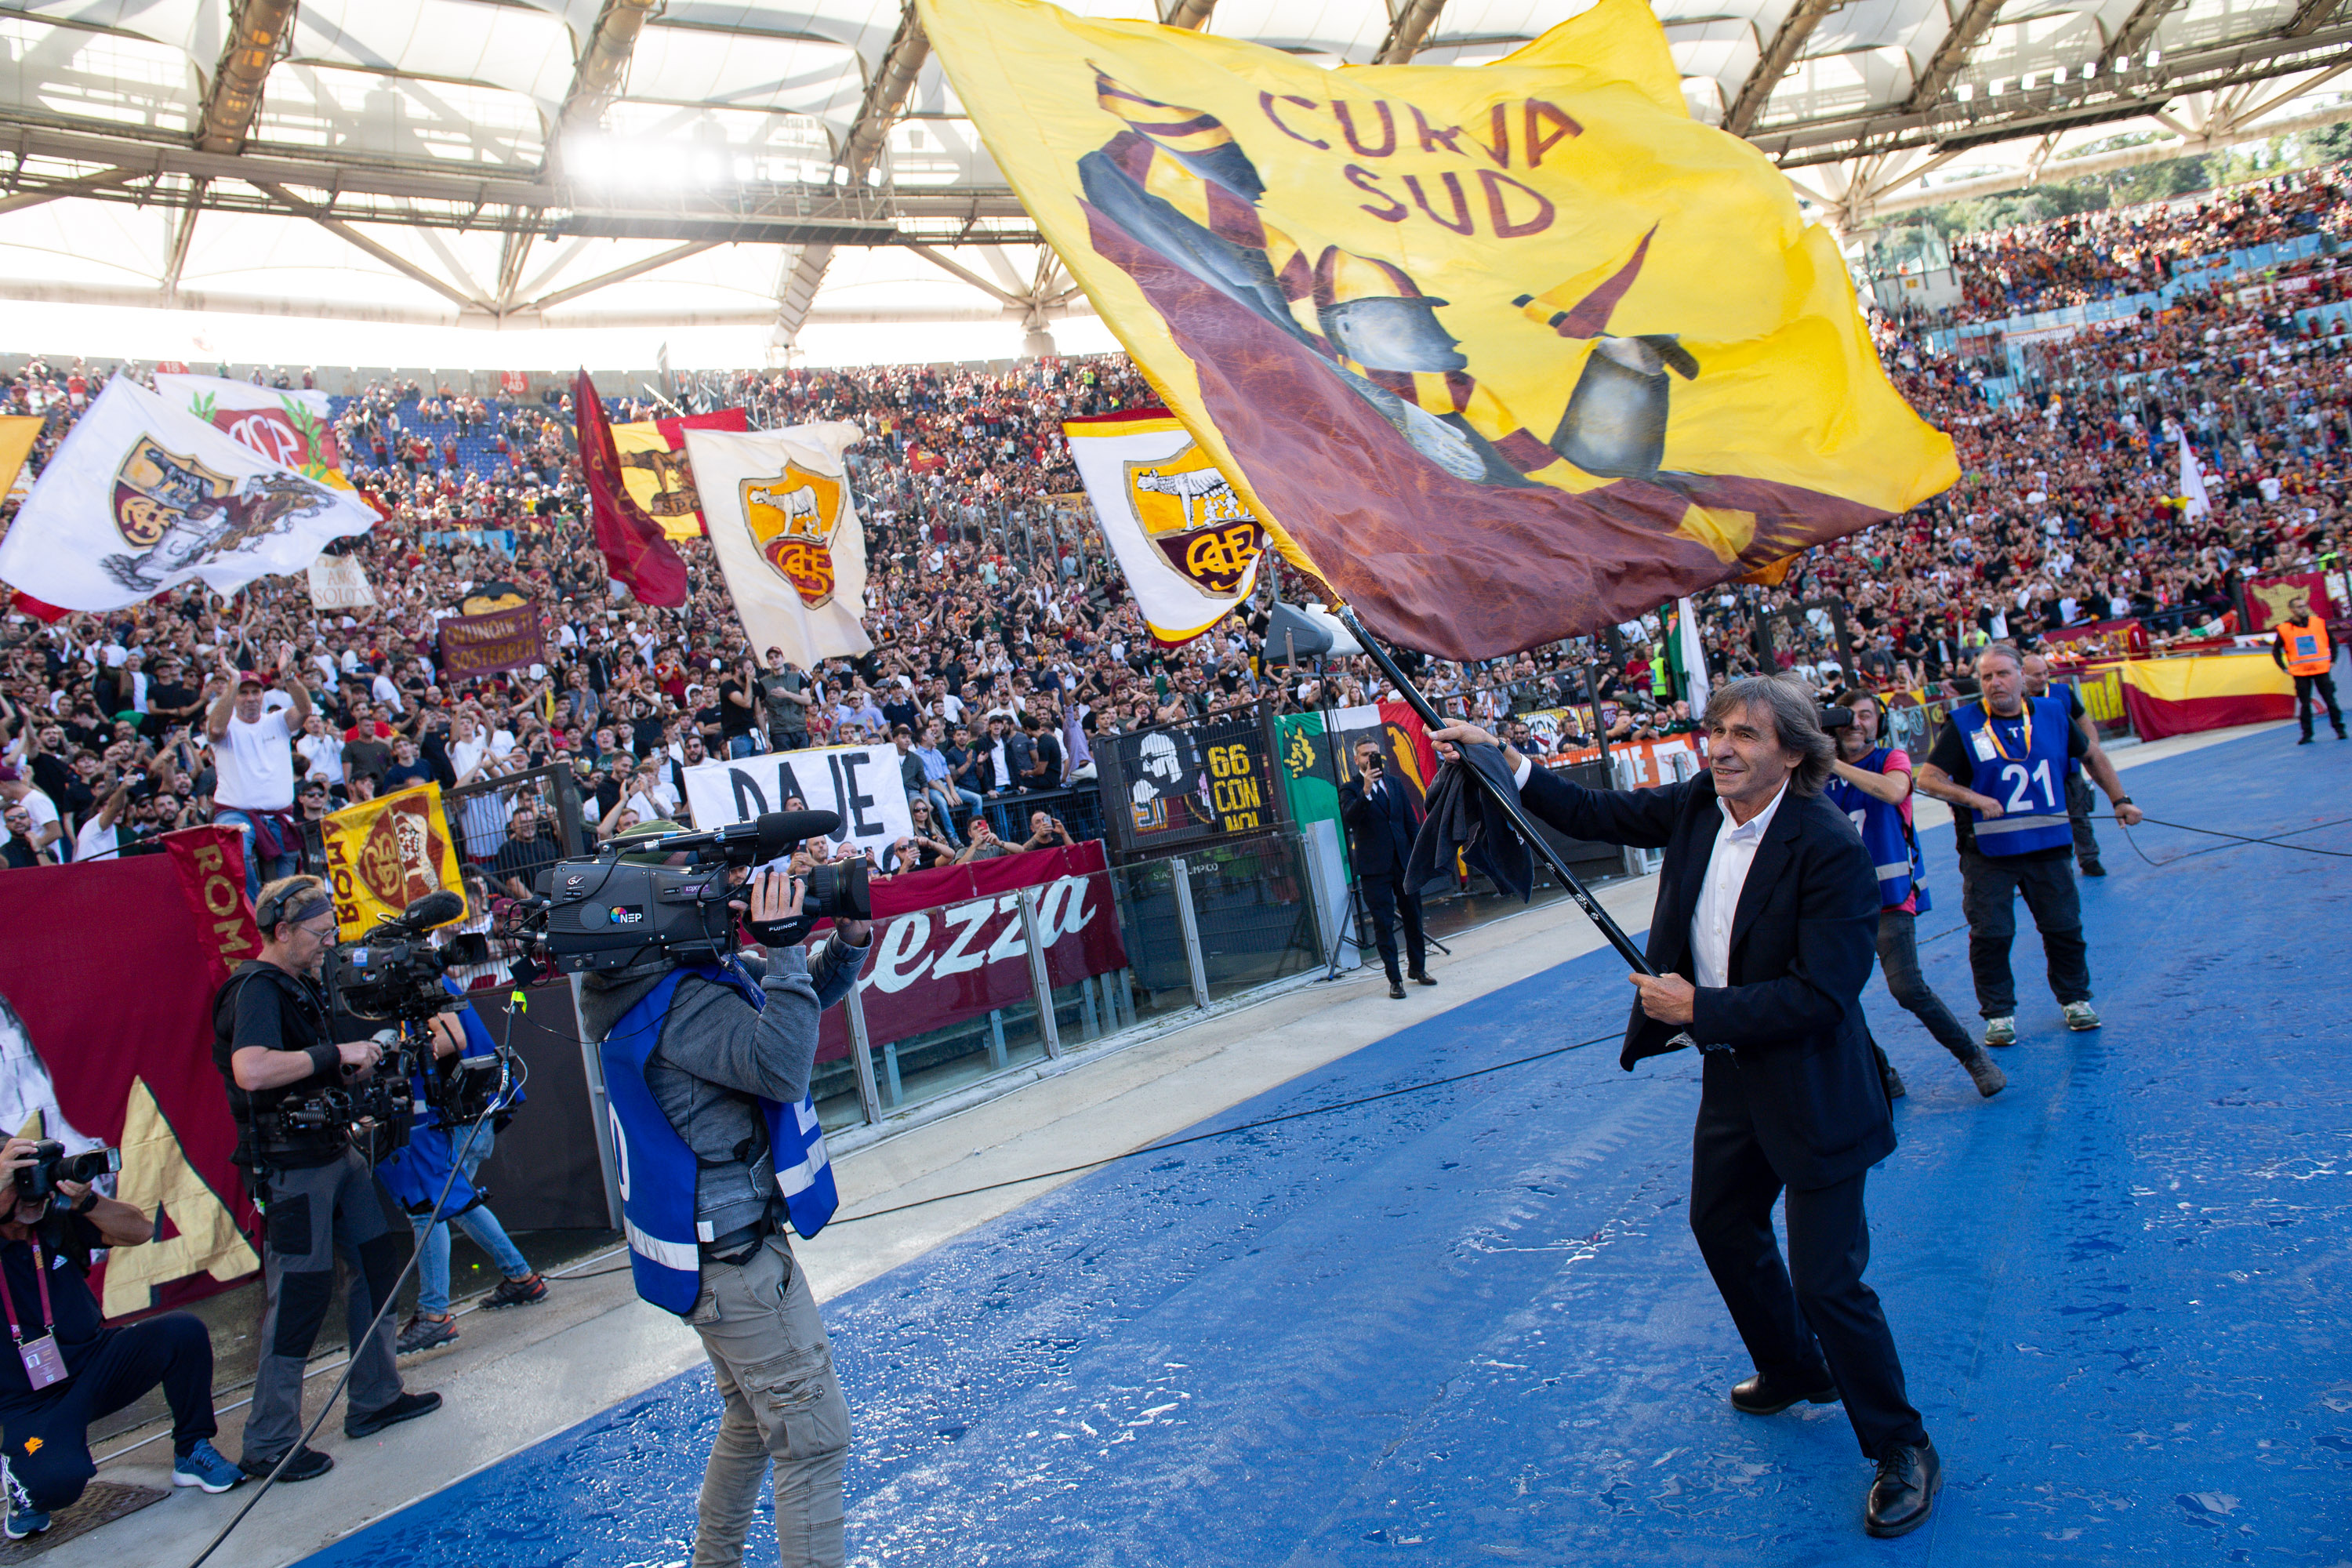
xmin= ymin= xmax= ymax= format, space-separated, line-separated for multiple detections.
xmin=1691 ymin=1098 xmax=1926 ymax=1460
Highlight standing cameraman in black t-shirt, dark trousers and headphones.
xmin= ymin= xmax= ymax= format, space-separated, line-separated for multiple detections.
xmin=212 ymin=877 xmax=456 ymax=1481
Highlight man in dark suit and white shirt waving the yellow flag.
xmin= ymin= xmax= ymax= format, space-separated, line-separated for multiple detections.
xmin=1437 ymin=677 xmax=1943 ymax=1535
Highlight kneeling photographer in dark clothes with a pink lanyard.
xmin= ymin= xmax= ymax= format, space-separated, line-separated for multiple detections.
xmin=0 ymin=1138 xmax=245 ymax=1540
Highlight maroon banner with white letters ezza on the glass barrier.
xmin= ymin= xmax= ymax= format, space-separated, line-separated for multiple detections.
xmin=816 ymin=860 xmax=1127 ymax=1062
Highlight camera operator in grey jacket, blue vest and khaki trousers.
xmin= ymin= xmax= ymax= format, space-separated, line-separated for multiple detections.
xmin=581 ymin=855 xmax=870 ymax=1568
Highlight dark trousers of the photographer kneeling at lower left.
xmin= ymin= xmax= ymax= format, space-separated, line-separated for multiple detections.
xmin=0 ymin=1312 xmax=219 ymax=1514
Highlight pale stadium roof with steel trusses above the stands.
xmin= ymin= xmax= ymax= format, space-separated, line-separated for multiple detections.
xmin=0 ymin=0 xmax=2352 ymax=354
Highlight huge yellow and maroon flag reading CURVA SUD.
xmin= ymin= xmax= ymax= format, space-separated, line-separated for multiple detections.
xmin=920 ymin=0 xmax=1959 ymax=659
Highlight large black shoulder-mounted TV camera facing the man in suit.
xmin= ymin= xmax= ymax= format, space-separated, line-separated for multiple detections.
xmin=524 ymin=811 xmax=873 ymax=973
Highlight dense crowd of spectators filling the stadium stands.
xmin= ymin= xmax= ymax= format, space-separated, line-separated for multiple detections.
xmin=0 ymin=172 xmax=2352 ymax=886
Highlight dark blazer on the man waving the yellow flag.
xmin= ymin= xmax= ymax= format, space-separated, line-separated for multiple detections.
xmin=1522 ymin=769 xmax=1896 ymax=1189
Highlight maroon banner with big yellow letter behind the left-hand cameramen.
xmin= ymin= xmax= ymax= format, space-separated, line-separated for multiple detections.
xmin=0 ymin=827 xmax=261 ymax=1319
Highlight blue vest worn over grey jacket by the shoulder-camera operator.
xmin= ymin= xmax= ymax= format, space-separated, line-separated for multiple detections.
xmin=597 ymin=964 xmax=842 ymax=1316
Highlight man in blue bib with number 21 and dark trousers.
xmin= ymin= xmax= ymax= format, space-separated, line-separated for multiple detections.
xmin=1919 ymin=642 xmax=2140 ymax=1046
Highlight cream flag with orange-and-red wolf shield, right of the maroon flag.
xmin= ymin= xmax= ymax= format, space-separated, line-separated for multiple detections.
xmin=684 ymin=421 xmax=873 ymax=668
